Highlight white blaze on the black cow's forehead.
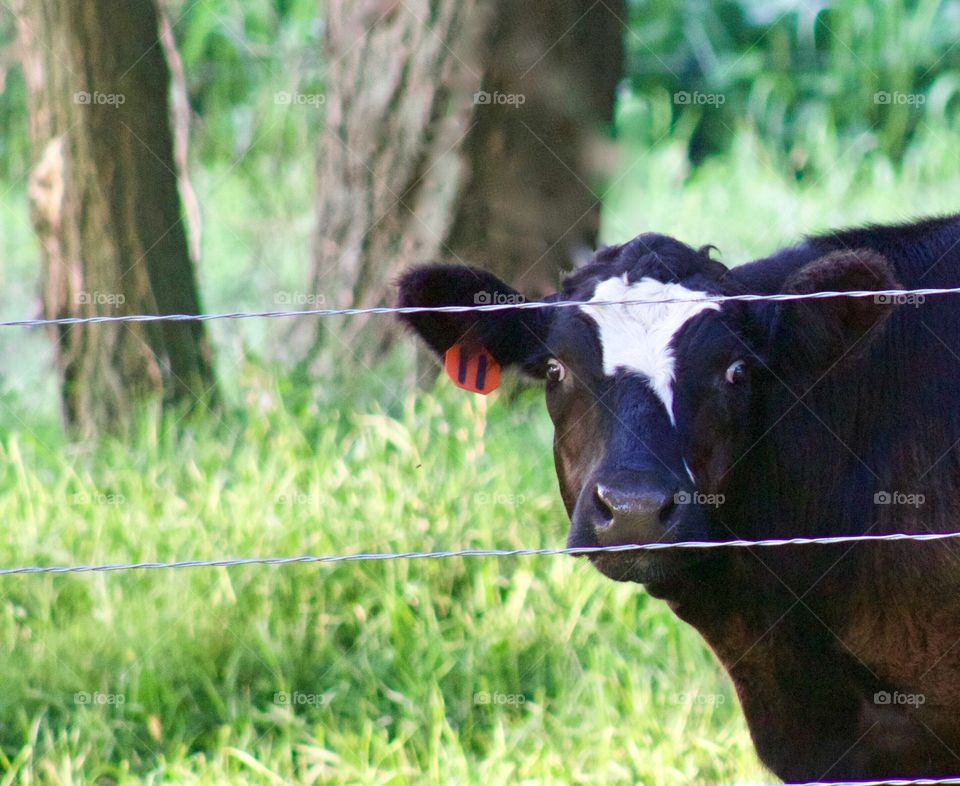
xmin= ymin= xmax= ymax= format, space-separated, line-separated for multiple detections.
xmin=580 ymin=273 xmax=720 ymax=423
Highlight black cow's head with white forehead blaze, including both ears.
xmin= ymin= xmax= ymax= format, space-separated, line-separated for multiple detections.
xmin=399 ymin=234 xmax=897 ymax=583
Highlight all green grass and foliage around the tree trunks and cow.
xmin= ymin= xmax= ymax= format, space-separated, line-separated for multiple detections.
xmin=0 ymin=0 xmax=960 ymax=784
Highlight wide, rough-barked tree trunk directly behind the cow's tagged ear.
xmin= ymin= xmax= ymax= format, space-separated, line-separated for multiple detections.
xmin=311 ymin=0 xmax=624 ymax=360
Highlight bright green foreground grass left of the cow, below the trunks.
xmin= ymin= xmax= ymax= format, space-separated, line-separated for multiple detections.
xmin=0 ymin=358 xmax=760 ymax=784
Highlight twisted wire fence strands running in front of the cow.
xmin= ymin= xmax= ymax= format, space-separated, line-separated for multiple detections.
xmin=7 ymin=278 xmax=960 ymax=786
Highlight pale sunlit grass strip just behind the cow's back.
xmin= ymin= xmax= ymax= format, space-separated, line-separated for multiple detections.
xmin=598 ymin=119 xmax=960 ymax=256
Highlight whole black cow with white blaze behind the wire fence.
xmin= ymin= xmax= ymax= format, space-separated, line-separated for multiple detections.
xmin=400 ymin=211 xmax=960 ymax=780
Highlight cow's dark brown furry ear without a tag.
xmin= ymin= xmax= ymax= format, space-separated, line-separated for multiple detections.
xmin=771 ymin=249 xmax=902 ymax=373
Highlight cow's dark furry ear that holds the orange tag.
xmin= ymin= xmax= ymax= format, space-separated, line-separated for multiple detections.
xmin=398 ymin=265 xmax=553 ymax=392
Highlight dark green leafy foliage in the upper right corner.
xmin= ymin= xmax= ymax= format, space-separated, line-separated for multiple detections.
xmin=620 ymin=0 xmax=960 ymax=171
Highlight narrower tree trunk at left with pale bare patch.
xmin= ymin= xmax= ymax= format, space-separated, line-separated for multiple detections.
xmin=18 ymin=0 xmax=215 ymax=432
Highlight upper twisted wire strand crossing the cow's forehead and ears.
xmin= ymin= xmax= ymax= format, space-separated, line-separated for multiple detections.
xmin=0 ymin=287 xmax=960 ymax=328
